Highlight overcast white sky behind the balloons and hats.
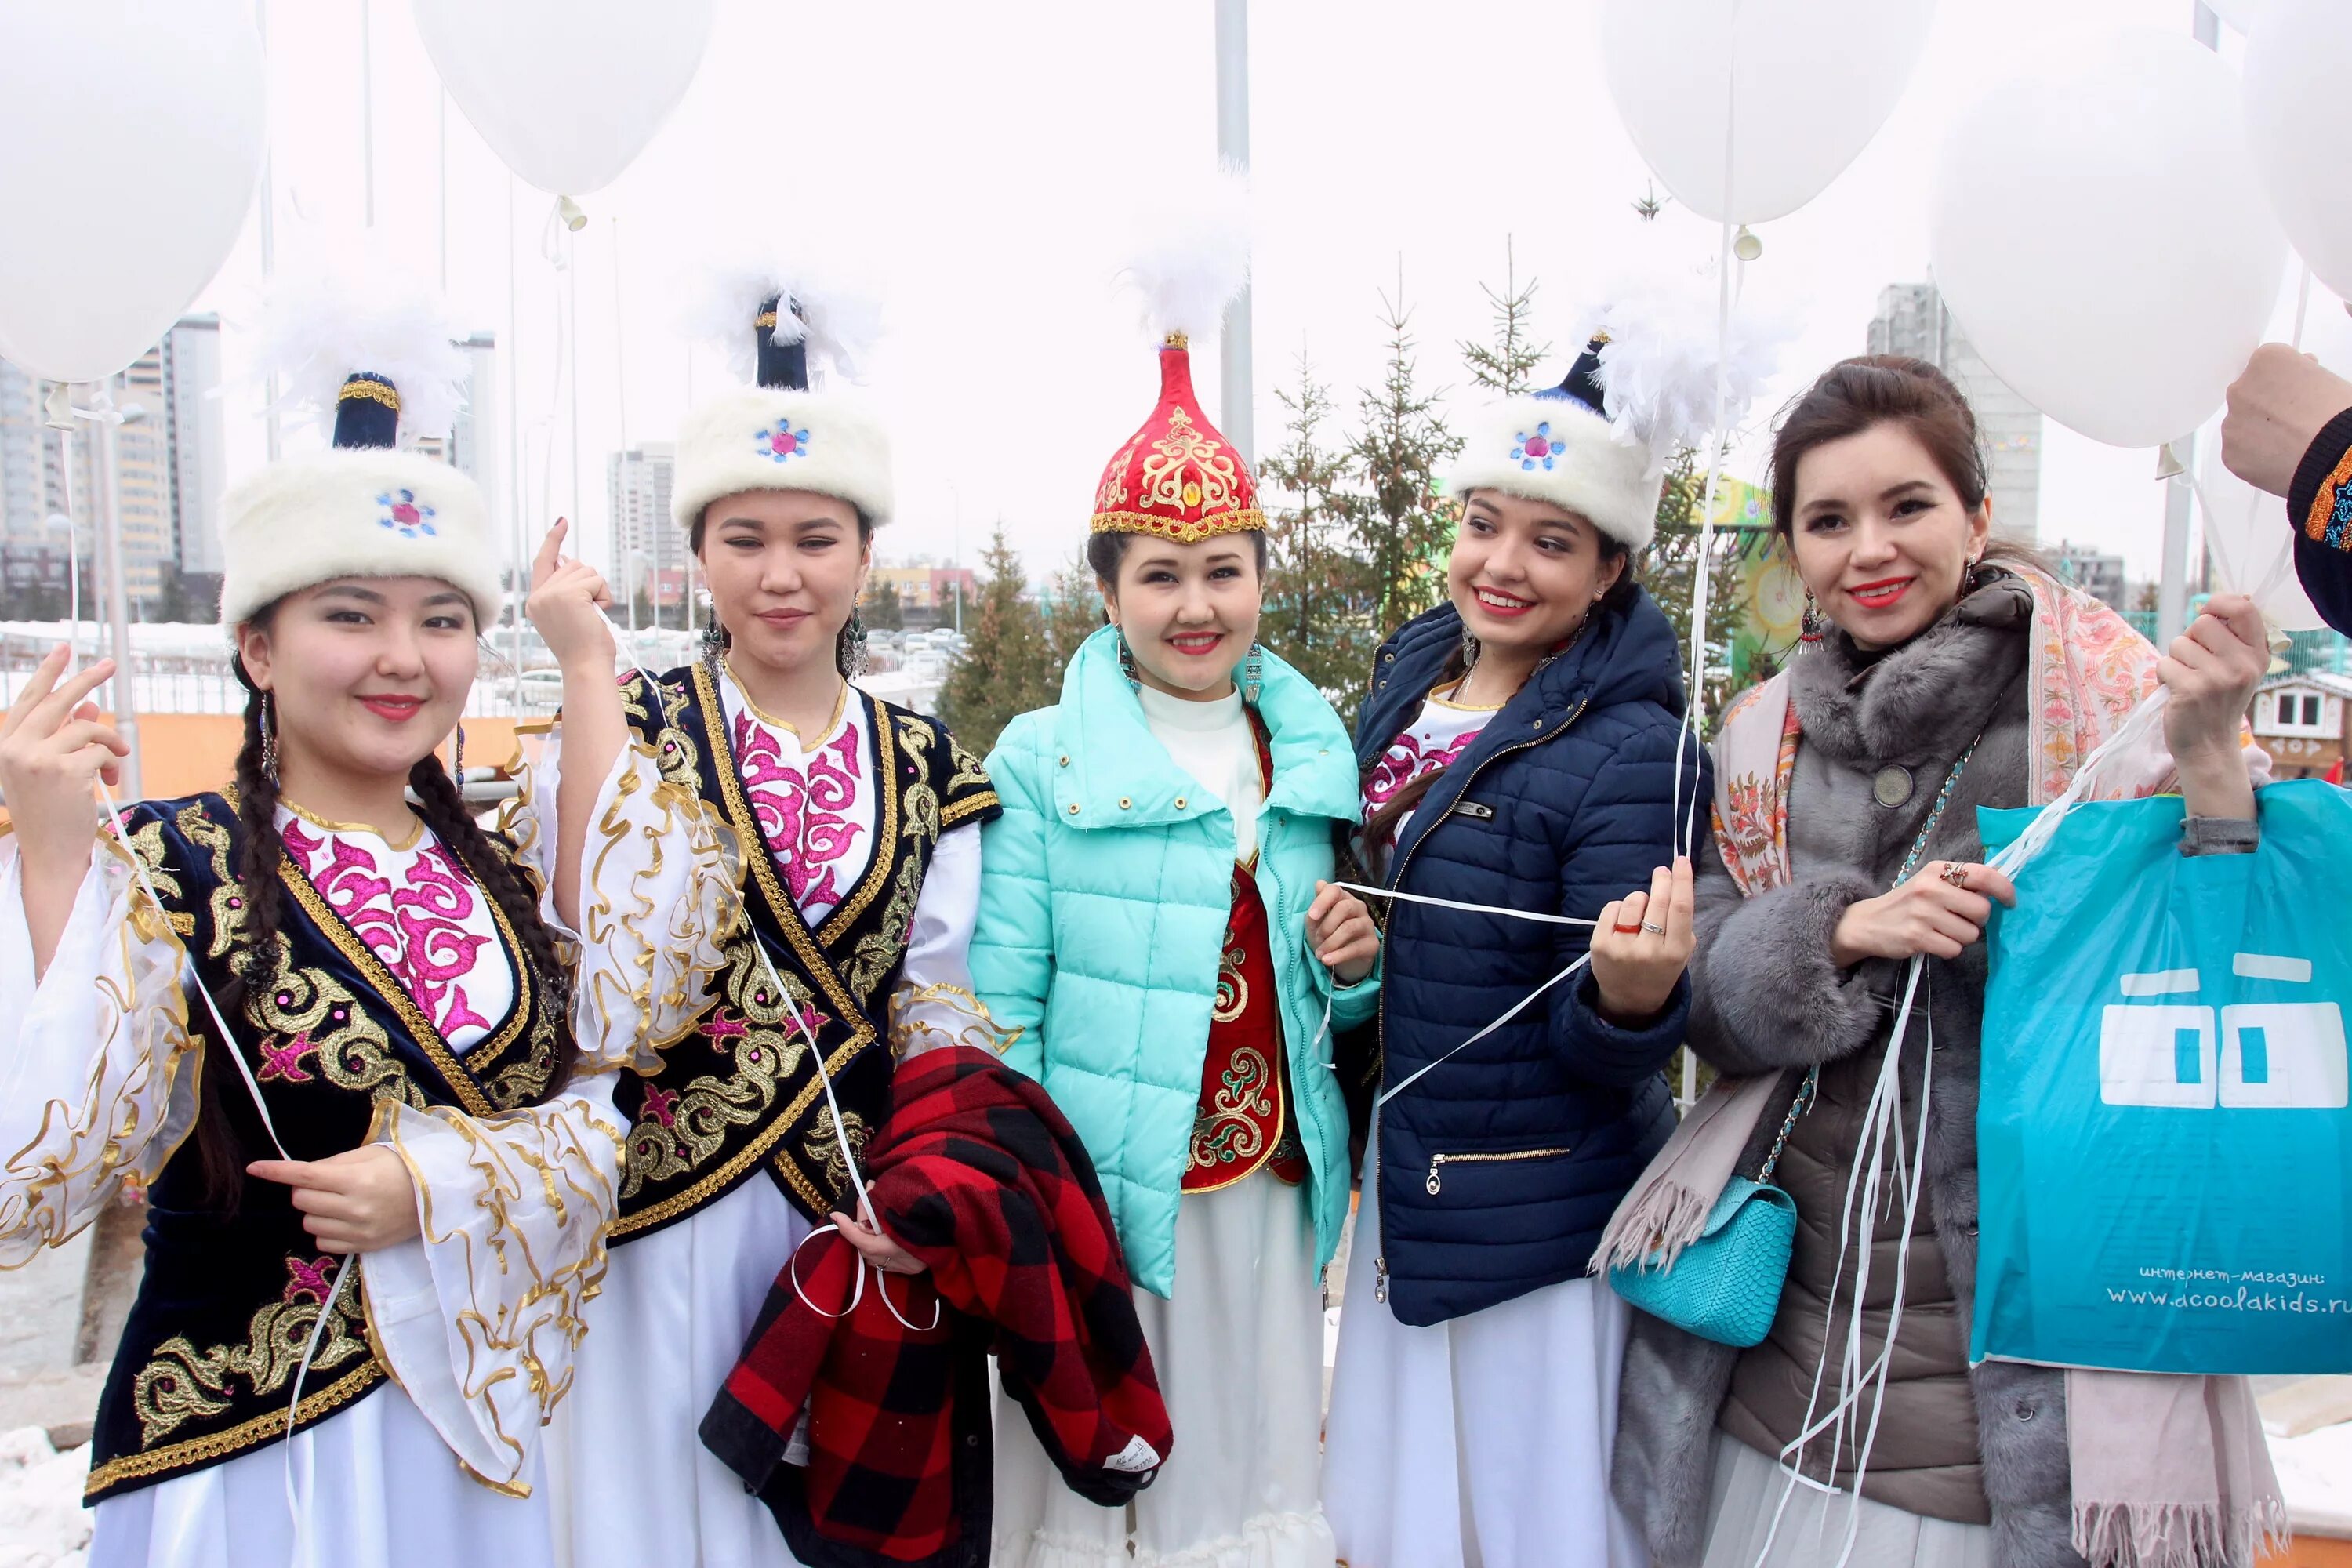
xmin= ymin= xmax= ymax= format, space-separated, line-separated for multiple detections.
xmin=198 ymin=0 xmax=2352 ymax=587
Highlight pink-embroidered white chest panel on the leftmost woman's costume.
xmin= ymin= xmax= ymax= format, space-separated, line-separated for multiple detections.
xmin=285 ymin=820 xmax=492 ymax=1044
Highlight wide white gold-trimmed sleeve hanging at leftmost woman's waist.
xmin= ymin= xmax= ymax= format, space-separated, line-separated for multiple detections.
xmin=360 ymin=1062 xmax=621 ymax=1495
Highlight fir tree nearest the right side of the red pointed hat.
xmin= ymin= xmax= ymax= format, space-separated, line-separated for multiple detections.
xmin=1258 ymin=353 xmax=1381 ymax=724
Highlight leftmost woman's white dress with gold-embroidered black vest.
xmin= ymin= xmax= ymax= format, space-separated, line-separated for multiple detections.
xmin=0 ymin=753 xmax=708 ymax=1568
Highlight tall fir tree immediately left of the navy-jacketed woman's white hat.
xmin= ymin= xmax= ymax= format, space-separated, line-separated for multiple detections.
xmin=1334 ymin=266 xmax=1463 ymax=640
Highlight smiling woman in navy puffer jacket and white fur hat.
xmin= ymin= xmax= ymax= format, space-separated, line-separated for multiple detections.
xmin=1324 ymin=343 xmax=1710 ymax=1568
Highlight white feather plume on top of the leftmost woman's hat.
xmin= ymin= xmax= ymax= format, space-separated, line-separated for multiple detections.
xmin=254 ymin=252 xmax=468 ymax=440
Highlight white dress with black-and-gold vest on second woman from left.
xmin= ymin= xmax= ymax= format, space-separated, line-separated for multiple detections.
xmin=550 ymin=666 xmax=1000 ymax=1568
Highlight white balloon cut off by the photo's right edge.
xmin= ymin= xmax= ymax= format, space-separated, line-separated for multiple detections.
xmin=2246 ymin=0 xmax=2352 ymax=296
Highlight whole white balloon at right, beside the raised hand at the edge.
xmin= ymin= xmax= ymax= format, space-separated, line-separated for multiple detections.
xmin=1929 ymin=28 xmax=2286 ymax=447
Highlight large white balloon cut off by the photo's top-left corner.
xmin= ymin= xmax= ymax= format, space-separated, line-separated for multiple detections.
xmin=0 ymin=0 xmax=266 ymax=381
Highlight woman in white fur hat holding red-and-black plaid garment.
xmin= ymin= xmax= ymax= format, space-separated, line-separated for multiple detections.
xmin=557 ymin=270 xmax=997 ymax=1568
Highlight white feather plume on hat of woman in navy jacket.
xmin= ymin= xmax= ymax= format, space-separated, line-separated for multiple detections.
xmin=1588 ymin=268 xmax=1795 ymax=470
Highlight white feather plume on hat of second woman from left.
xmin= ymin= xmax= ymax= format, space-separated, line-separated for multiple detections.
xmin=677 ymin=235 xmax=882 ymax=383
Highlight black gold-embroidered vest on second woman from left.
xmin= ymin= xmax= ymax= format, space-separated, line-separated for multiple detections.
xmin=614 ymin=663 xmax=1000 ymax=1241
